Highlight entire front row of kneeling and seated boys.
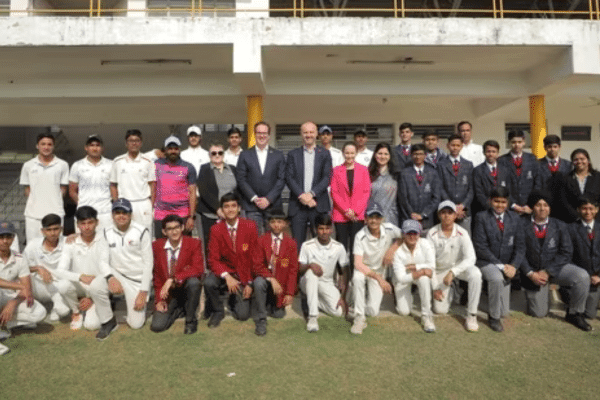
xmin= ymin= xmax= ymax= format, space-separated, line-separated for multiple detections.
xmin=0 ymin=187 xmax=600 ymax=348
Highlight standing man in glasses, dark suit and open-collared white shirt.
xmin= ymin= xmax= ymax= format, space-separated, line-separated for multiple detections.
xmin=237 ymin=121 xmax=285 ymax=234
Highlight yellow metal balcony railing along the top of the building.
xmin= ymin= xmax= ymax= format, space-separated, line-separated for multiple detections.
xmin=0 ymin=0 xmax=600 ymax=20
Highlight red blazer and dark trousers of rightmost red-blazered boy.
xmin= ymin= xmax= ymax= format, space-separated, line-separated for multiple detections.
xmin=253 ymin=232 xmax=298 ymax=321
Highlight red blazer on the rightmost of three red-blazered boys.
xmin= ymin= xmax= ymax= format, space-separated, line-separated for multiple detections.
xmin=254 ymin=232 xmax=298 ymax=307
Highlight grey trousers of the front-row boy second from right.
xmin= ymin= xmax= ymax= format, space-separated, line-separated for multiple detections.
xmin=524 ymin=264 xmax=590 ymax=318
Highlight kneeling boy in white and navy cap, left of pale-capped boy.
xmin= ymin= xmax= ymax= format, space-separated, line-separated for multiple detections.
xmin=350 ymin=203 xmax=402 ymax=335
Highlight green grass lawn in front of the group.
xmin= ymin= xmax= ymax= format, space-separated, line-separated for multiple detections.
xmin=0 ymin=312 xmax=600 ymax=399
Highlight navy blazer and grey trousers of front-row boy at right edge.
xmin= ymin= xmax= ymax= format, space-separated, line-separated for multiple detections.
xmin=569 ymin=220 xmax=600 ymax=318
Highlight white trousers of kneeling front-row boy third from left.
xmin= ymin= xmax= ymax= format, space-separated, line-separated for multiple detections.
xmin=64 ymin=276 xmax=113 ymax=331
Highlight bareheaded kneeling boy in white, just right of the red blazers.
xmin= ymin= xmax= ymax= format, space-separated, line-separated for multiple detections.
xmin=298 ymin=214 xmax=348 ymax=332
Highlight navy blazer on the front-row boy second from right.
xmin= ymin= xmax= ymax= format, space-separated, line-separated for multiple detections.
xmin=521 ymin=217 xmax=573 ymax=290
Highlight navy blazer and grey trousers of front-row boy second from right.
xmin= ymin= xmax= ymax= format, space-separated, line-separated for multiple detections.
xmin=521 ymin=218 xmax=590 ymax=318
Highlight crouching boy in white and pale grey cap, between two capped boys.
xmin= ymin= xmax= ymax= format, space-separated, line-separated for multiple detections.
xmin=393 ymin=219 xmax=435 ymax=333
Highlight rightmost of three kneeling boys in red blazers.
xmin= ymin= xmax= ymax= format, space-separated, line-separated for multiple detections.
xmin=252 ymin=212 xmax=298 ymax=336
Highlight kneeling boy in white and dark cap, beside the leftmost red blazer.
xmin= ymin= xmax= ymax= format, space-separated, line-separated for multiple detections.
xmin=104 ymin=199 xmax=153 ymax=329
